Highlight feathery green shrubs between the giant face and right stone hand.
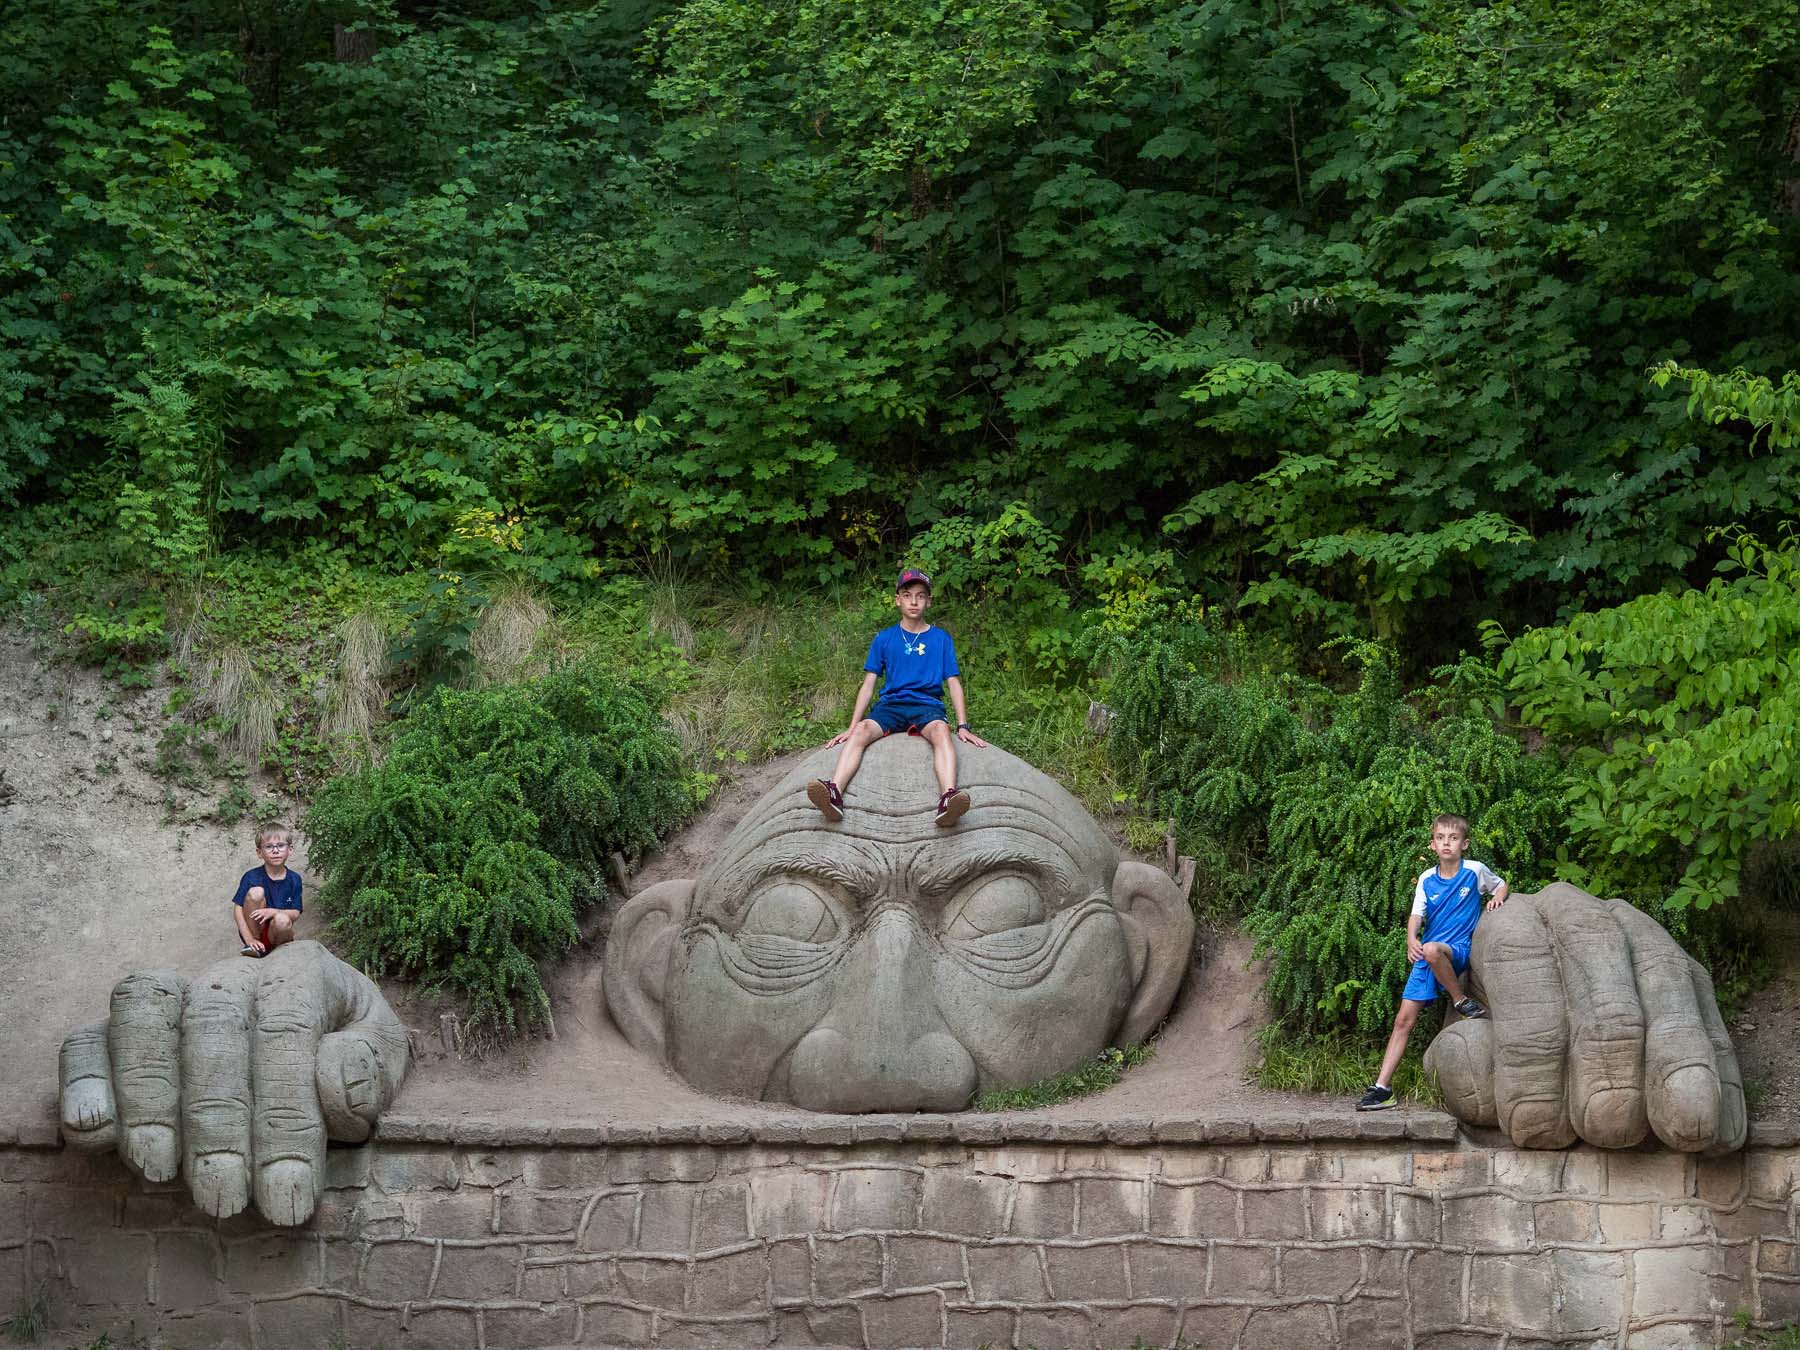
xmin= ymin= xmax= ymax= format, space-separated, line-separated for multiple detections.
xmin=1112 ymin=628 xmax=1566 ymax=1033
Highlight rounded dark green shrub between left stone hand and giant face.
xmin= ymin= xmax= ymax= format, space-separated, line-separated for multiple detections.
xmin=306 ymin=666 xmax=689 ymax=1030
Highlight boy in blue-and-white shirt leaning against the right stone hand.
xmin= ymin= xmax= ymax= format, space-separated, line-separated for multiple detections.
xmin=1355 ymin=815 xmax=1508 ymax=1111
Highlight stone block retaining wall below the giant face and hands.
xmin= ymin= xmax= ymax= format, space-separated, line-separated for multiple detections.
xmin=0 ymin=1118 xmax=1800 ymax=1350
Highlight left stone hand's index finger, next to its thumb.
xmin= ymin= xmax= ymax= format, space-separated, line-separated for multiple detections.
xmin=250 ymin=941 xmax=326 ymax=1224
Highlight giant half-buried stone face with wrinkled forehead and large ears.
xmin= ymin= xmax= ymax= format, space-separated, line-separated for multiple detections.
xmin=605 ymin=736 xmax=1193 ymax=1111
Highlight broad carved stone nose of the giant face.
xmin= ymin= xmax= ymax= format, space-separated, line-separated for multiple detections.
xmin=788 ymin=909 xmax=976 ymax=1111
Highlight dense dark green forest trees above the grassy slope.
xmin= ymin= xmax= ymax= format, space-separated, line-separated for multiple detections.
xmin=0 ymin=0 xmax=1800 ymax=651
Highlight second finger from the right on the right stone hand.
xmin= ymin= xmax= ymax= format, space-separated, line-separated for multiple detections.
xmin=1615 ymin=902 xmax=1719 ymax=1152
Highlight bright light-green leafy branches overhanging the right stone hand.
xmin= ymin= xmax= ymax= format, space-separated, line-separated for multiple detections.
xmin=1503 ymin=535 xmax=1800 ymax=911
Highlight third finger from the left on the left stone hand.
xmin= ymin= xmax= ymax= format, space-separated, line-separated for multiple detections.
xmin=182 ymin=961 xmax=261 ymax=1219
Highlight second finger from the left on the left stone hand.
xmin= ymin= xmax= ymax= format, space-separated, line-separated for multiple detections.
xmin=106 ymin=970 xmax=187 ymax=1181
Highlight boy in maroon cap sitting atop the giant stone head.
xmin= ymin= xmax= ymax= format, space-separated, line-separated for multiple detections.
xmin=806 ymin=567 xmax=986 ymax=826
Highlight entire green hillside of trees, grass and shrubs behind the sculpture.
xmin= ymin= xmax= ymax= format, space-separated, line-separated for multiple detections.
xmin=0 ymin=0 xmax=1800 ymax=1091
